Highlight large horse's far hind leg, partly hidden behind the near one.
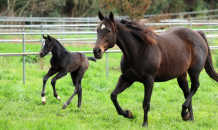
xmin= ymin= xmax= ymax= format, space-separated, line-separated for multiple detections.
xmin=177 ymin=73 xmax=194 ymax=120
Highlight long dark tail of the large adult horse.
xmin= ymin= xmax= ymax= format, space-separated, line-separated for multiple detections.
xmin=197 ymin=30 xmax=218 ymax=82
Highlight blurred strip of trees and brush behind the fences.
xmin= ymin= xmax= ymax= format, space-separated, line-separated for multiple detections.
xmin=0 ymin=0 xmax=218 ymax=17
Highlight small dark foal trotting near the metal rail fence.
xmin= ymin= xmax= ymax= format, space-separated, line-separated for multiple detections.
xmin=39 ymin=35 xmax=96 ymax=109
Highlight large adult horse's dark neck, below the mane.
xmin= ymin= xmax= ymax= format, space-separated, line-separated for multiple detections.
xmin=116 ymin=31 xmax=141 ymax=61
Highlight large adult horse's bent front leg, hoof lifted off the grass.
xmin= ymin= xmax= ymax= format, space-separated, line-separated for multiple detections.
xmin=111 ymin=75 xmax=133 ymax=119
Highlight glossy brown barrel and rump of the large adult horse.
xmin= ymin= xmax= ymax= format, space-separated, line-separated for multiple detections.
xmin=155 ymin=27 xmax=207 ymax=81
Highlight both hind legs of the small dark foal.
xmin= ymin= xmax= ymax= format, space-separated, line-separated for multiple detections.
xmin=62 ymin=68 xmax=85 ymax=109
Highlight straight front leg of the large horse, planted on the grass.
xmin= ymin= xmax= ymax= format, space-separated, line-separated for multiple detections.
xmin=142 ymin=75 xmax=154 ymax=127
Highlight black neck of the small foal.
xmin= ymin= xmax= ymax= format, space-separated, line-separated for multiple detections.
xmin=51 ymin=42 xmax=66 ymax=59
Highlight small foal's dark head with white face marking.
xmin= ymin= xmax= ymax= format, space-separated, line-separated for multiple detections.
xmin=39 ymin=35 xmax=54 ymax=58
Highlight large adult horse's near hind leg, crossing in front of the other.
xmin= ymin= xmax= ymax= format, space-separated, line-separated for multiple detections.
xmin=182 ymin=70 xmax=200 ymax=120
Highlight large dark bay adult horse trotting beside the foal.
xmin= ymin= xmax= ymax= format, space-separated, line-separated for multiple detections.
xmin=93 ymin=11 xmax=218 ymax=126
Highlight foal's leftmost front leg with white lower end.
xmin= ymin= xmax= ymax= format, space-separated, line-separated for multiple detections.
xmin=41 ymin=68 xmax=57 ymax=104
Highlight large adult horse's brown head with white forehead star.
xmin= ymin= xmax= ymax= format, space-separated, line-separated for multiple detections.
xmin=93 ymin=11 xmax=117 ymax=59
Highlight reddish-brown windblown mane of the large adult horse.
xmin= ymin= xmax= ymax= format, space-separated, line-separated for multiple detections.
xmin=105 ymin=17 xmax=157 ymax=46
